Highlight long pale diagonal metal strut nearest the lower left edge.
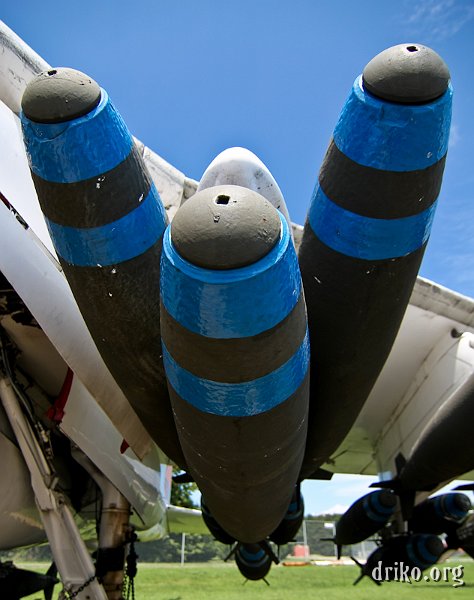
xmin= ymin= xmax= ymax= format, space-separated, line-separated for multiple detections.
xmin=0 ymin=374 xmax=107 ymax=600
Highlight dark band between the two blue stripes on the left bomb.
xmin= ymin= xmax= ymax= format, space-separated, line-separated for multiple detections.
xmin=32 ymin=144 xmax=151 ymax=227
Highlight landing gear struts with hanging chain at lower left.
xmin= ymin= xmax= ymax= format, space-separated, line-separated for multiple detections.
xmin=0 ymin=372 xmax=134 ymax=600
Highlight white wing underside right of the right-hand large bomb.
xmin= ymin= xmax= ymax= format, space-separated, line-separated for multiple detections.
xmin=318 ymin=277 xmax=474 ymax=479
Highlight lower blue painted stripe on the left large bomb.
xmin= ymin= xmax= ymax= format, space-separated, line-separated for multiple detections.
xmin=46 ymin=185 xmax=166 ymax=267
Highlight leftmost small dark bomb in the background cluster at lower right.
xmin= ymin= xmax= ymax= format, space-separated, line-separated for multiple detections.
xmin=334 ymin=490 xmax=397 ymax=546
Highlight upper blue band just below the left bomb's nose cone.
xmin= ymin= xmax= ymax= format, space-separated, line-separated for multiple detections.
xmin=20 ymin=90 xmax=132 ymax=183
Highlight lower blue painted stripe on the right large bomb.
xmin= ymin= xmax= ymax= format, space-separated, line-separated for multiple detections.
xmin=309 ymin=186 xmax=437 ymax=260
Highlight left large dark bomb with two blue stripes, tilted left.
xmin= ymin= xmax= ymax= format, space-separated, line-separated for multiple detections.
xmin=21 ymin=69 xmax=184 ymax=466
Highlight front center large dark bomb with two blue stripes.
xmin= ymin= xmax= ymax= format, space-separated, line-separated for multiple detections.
xmin=161 ymin=185 xmax=309 ymax=543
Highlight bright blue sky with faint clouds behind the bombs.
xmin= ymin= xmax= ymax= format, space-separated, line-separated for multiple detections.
xmin=4 ymin=0 xmax=474 ymax=513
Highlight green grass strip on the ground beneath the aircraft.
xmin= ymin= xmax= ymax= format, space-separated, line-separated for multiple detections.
xmin=18 ymin=560 xmax=474 ymax=600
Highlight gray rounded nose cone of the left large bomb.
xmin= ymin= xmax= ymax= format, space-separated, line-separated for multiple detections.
xmin=21 ymin=67 xmax=100 ymax=123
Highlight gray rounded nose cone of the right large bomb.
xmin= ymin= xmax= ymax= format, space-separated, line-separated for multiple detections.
xmin=362 ymin=44 xmax=450 ymax=104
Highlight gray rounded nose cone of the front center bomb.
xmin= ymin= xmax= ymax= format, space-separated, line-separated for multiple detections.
xmin=171 ymin=185 xmax=281 ymax=270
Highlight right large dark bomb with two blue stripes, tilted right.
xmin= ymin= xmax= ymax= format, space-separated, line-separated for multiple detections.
xmin=299 ymin=44 xmax=452 ymax=476
